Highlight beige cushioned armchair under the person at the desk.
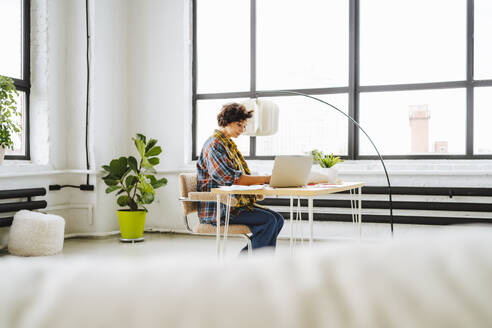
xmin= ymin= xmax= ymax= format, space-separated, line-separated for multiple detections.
xmin=179 ymin=173 xmax=258 ymax=256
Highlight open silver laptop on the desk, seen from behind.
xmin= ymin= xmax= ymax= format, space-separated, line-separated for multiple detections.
xmin=270 ymin=155 xmax=313 ymax=188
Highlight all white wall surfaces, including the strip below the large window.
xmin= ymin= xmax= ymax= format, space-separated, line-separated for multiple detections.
xmin=0 ymin=0 xmax=492 ymax=246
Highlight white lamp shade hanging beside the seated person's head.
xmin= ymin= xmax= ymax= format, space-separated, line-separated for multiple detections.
xmin=242 ymin=99 xmax=279 ymax=136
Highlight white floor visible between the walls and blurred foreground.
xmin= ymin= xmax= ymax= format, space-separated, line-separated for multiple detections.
xmin=0 ymin=221 xmax=446 ymax=258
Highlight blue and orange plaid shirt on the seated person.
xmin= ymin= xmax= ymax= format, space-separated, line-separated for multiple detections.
xmin=196 ymin=135 xmax=243 ymax=223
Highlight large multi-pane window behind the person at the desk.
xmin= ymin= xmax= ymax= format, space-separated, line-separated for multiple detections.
xmin=193 ymin=0 xmax=492 ymax=159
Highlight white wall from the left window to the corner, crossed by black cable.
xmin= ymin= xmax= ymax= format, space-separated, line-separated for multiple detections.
xmin=0 ymin=0 xmax=129 ymax=247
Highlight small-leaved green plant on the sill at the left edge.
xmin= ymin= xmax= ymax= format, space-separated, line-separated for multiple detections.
xmin=0 ymin=75 xmax=21 ymax=164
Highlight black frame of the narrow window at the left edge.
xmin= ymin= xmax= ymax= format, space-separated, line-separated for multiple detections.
xmin=5 ymin=0 xmax=31 ymax=160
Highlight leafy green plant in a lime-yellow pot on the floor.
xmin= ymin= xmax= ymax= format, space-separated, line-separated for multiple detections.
xmin=102 ymin=134 xmax=167 ymax=242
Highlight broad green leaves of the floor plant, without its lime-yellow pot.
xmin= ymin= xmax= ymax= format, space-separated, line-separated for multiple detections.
xmin=102 ymin=134 xmax=167 ymax=211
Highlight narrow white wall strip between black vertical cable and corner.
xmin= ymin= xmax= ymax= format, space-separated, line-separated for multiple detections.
xmin=92 ymin=0 xmax=131 ymax=232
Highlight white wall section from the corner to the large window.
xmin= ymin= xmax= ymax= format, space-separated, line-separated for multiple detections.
xmin=128 ymin=0 xmax=191 ymax=230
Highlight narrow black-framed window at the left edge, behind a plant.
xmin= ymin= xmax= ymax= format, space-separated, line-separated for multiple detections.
xmin=0 ymin=0 xmax=30 ymax=159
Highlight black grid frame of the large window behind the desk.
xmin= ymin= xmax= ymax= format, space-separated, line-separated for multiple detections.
xmin=192 ymin=0 xmax=492 ymax=160
